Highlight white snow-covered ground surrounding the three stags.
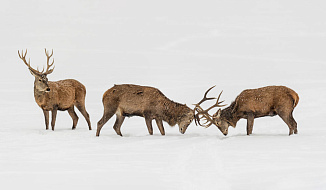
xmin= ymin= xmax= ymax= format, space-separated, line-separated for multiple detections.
xmin=0 ymin=0 xmax=326 ymax=190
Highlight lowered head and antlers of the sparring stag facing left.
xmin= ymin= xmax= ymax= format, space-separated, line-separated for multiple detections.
xmin=194 ymin=86 xmax=229 ymax=135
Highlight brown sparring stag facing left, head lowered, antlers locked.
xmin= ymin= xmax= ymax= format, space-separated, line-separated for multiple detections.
xmin=194 ymin=86 xmax=299 ymax=135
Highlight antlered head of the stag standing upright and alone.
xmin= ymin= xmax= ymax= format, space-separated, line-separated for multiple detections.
xmin=18 ymin=49 xmax=54 ymax=92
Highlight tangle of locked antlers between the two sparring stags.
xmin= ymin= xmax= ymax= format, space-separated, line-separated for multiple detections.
xmin=194 ymin=86 xmax=225 ymax=128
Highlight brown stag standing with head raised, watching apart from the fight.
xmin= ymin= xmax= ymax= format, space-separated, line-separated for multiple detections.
xmin=18 ymin=49 xmax=92 ymax=130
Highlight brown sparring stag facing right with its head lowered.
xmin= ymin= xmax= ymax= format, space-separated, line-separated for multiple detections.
xmin=96 ymin=84 xmax=194 ymax=136
